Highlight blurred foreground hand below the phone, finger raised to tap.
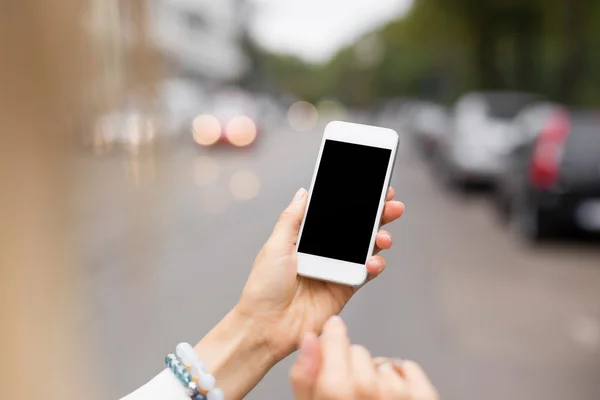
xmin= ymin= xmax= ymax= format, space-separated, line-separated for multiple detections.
xmin=290 ymin=316 xmax=438 ymax=400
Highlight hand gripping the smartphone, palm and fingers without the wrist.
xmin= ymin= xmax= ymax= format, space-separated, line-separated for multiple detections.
xmin=234 ymin=188 xmax=404 ymax=362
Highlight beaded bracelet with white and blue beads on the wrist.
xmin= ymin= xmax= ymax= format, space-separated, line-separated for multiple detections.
xmin=165 ymin=343 xmax=224 ymax=400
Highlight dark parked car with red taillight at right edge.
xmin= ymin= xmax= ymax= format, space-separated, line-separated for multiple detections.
xmin=497 ymin=107 xmax=600 ymax=242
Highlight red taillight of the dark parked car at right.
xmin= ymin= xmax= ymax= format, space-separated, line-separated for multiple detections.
xmin=530 ymin=112 xmax=571 ymax=189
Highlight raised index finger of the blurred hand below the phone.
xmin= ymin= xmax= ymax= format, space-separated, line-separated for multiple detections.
xmin=321 ymin=315 xmax=350 ymax=380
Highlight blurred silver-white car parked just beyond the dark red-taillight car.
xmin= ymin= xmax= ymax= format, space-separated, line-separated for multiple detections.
xmin=436 ymin=92 xmax=539 ymax=187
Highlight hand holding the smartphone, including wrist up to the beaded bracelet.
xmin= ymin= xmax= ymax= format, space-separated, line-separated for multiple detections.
xmin=196 ymin=188 xmax=404 ymax=400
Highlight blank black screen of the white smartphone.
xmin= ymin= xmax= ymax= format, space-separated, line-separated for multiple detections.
xmin=298 ymin=140 xmax=392 ymax=264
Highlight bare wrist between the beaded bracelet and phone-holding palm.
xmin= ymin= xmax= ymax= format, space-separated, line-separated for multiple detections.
xmin=195 ymin=309 xmax=278 ymax=399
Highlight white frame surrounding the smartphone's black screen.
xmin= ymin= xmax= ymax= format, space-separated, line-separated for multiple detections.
xmin=296 ymin=121 xmax=399 ymax=286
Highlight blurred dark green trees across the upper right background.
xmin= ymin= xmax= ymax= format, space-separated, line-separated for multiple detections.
xmin=254 ymin=0 xmax=600 ymax=106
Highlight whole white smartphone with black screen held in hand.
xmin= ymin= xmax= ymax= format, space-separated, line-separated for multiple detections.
xmin=296 ymin=121 xmax=398 ymax=286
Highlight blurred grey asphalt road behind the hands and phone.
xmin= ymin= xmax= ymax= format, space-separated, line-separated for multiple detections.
xmin=74 ymin=122 xmax=600 ymax=400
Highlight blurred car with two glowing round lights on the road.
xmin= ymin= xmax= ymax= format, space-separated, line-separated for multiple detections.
xmin=192 ymin=89 xmax=263 ymax=148
